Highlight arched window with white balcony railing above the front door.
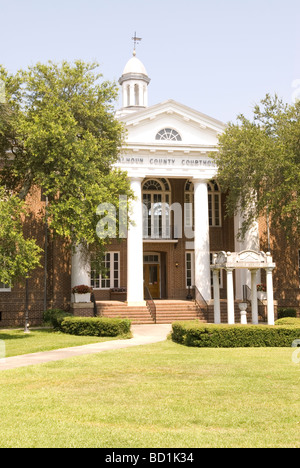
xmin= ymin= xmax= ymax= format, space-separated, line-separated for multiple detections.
xmin=143 ymin=179 xmax=171 ymax=239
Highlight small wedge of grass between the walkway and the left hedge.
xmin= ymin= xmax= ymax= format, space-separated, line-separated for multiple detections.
xmin=0 ymin=329 xmax=123 ymax=357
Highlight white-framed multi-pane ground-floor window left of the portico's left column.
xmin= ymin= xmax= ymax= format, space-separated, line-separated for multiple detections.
xmin=91 ymin=252 xmax=120 ymax=289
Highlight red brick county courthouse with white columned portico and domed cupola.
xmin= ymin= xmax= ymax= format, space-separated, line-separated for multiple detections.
xmin=0 ymin=52 xmax=299 ymax=326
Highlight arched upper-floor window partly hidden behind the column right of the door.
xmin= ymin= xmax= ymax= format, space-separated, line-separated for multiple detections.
xmin=184 ymin=180 xmax=221 ymax=227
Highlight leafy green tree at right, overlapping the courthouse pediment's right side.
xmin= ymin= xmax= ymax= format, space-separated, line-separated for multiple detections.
xmin=213 ymin=95 xmax=300 ymax=241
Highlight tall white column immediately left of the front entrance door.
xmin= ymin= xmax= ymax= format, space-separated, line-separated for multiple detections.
xmin=127 ymin=177 xmax=145 ymax=306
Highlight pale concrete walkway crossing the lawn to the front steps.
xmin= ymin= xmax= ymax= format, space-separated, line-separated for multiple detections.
xmin=0 ymin=324 xmax=172 ymax=371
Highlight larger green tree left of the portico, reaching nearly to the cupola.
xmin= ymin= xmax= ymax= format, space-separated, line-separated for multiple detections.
xmin=0 ymin=61 xmax=131 ymax=266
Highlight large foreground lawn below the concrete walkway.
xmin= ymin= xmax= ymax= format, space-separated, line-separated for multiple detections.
xmin=0 ymin=341 xmax=300 ymax=448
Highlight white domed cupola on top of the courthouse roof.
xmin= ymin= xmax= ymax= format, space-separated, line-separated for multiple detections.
xmin=119 ymin=50 xmax=150 ymax=111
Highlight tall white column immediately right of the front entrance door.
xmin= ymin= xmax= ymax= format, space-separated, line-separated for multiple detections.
xmin=193 ymin=180 xmax=211 ymax=301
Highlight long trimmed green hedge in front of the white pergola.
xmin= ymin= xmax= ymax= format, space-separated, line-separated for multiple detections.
xmin=172 ymin=320 xmax=300 ymax=348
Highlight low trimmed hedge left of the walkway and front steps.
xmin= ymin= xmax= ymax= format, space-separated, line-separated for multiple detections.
xmin=60 ymin=317 xmax=131 ymax=336
